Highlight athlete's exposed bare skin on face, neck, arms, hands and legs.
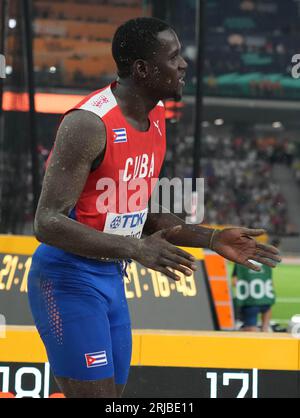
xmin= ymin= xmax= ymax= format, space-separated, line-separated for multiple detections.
xmin=35 ymin=29 xmax=280 ymax=397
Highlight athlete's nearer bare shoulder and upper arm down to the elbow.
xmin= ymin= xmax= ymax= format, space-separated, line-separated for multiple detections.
xmin=36 ymin=110 xmax=106 ymax=222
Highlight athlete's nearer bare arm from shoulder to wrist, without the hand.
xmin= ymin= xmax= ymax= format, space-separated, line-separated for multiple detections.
xmin=35 ymin=111 xmax=137 ymax=259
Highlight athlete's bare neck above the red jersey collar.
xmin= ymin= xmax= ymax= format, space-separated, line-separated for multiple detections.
xmin=113 ymin=78 xmax=159 ymax=122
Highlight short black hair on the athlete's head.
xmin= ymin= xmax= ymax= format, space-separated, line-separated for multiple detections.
xmin=112 ymin=17 xmax=173 ymax=78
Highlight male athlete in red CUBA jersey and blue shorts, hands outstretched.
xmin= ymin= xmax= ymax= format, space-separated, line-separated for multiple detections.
xmin=28 ymin=18 xmax=280 ymax=397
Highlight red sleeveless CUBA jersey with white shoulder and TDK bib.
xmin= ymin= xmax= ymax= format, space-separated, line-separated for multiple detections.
xmin=63 ymin=83 xmax=166 ymax=238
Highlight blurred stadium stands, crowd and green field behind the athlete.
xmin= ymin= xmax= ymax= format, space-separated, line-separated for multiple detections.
xmin=0 ymin=0 xmax=300 ymax=398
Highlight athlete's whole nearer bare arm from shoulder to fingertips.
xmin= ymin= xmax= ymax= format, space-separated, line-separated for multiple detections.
xmin=35 ymin=111 xmax=196 ymax=280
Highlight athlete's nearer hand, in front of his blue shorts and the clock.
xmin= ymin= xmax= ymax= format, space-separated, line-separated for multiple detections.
xmin=135 ymin=225 xmax=197 ymax=281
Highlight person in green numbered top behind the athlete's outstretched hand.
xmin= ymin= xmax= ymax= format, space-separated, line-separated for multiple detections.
xmin=232 ymin=239 xmax=280 ymax=332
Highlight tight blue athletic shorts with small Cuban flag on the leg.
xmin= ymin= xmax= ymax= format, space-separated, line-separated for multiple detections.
xmin=28 ymin=244 xmax=132 ymax=385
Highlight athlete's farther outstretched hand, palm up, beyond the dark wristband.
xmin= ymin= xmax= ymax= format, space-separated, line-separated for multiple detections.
xmin=212 ymin=228 xmax=281 ymax=271
